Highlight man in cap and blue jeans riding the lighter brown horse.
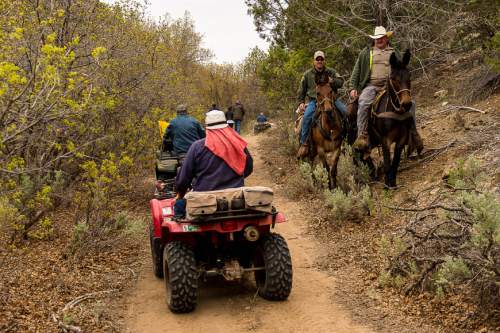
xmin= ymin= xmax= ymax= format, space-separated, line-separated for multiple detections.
xmin=297 ymin=51 xmax=347 ymax=157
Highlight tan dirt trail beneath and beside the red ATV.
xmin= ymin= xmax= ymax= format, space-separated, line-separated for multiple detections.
xmin=125 ymin=136 xmax=372 ymax=333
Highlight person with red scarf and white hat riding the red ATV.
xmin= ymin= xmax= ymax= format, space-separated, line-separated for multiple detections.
xmin=176 ymin=110 xmax=253 ymax=198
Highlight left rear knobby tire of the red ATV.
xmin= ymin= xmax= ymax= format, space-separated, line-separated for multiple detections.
xmin=163 ymin=241 xmax=199 ymax=313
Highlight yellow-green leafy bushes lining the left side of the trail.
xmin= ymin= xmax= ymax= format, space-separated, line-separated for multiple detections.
xmin=0 ymin=0 xmax=266 ymax=241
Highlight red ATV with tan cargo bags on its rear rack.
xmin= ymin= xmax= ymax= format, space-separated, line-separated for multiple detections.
xmin=150 ymin=187 xmax=292 ymax=313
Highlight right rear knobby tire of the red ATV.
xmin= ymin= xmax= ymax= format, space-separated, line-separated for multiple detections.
xmin=254 ymin=234 xmax=292 ymax=301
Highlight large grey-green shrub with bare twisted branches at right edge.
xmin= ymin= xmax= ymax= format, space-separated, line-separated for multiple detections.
xmin=382 ymin=158 xmax=500 ymax=305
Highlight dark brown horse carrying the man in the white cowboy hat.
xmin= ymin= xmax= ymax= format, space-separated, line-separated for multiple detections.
xmin=368 ymin=50 xmax=414 ymax=187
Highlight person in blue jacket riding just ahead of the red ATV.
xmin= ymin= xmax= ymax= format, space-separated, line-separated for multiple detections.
xmin=163 ymin=104 xmax=205 ymax=154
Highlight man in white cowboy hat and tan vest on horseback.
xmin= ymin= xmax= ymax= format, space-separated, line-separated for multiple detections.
xmin=350 ymin=26 xmax=423 ymax=153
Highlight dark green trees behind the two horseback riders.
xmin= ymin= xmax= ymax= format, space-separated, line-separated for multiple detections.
xmin=246 ymin=0 xmax=500 ymax=108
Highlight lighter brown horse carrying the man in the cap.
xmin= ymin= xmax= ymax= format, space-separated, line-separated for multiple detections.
xmin=309 ymin=73 xmax=343 ymax=189
